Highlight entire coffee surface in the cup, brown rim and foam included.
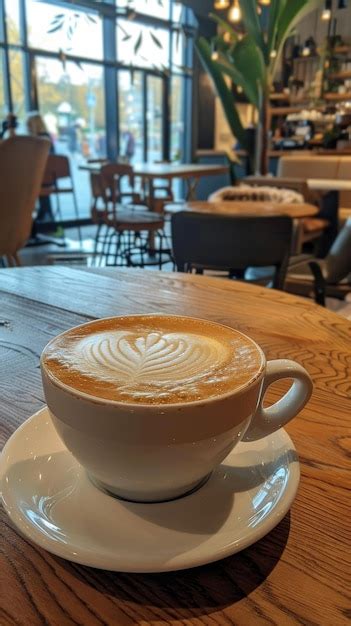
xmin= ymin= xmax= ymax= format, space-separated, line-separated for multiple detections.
xmin=43 ymin=315 xmax=264 ymax=405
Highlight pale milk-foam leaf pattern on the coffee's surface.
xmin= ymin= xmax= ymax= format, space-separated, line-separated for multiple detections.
xmin=71 ymin=331 xmax=228 ymax=393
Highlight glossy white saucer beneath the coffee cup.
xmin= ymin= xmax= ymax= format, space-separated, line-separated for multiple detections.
xmin=0 ymin=409 xmax=300 ymax=572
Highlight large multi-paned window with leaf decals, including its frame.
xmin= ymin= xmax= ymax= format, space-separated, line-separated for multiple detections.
xmin=0 ymin=0 xmax=195 ymax=173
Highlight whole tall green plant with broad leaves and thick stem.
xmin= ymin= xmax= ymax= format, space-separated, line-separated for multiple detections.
xmin=196 ymin=0 xmax=321 ymax=175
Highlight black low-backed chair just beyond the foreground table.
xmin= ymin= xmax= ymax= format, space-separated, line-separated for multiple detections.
xmin=172 ymin=211 xmax=292 ymax=289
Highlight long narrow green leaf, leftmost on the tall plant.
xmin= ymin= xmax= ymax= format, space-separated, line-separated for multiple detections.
xmin=195 ymin=37 xmax=249 ymax=148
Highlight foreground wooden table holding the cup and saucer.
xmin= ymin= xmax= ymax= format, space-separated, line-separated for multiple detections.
xmin=0 ymin=267 xmax=351 ymax=626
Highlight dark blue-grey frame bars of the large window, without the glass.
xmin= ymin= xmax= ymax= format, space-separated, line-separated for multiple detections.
xmin=0 ymin=0 xmax=197 ymax=160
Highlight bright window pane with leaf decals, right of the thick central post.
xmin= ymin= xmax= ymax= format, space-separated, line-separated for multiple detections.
xmin=117 ymin=19 xmax=170 ymax=68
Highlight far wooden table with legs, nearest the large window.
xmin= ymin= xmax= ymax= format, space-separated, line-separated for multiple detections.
xmin=79 ymin=163 xmax=229 ymax=209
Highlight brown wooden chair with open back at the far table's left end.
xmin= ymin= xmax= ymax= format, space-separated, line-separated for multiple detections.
xmin=90 ymin=163 xmax=168 ymax=267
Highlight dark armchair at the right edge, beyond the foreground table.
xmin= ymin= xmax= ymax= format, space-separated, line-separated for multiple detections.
xmin=288 ymin=218 xmax=351 ymax=306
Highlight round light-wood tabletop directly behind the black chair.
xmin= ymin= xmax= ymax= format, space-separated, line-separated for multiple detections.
xmin=172 ymin=200 xmax=319 ymax=219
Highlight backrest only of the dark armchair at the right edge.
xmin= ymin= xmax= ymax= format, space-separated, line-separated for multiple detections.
xmin=325 ymin=218 xmax=351 ymax=285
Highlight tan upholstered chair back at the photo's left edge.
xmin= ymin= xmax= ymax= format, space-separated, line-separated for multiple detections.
xmin=0 ymin=136 xmax=50 ymax=266
